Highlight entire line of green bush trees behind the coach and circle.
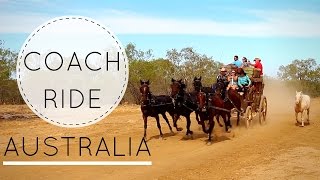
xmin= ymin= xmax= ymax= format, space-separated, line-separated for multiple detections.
xmin=0 ymin=41 xmax=320 ymax=104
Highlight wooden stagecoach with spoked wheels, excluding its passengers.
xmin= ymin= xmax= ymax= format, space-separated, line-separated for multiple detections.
xmin=228 ymin=66 xmax=267 ymax=128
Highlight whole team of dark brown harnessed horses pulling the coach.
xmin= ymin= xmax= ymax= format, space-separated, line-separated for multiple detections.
xmin=140 ymin=77 xmax=241 ymax=144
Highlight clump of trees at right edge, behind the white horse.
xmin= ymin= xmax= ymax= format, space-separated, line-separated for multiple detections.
xmin=278 ymin=59 xmax=320 ymax=97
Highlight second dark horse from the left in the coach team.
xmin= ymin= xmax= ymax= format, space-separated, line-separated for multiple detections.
xmin=171 ymin=78 xmax=198 ymax=136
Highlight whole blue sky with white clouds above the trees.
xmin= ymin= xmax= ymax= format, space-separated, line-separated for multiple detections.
xmin=0 ymin=0 xmax=320 ymax=76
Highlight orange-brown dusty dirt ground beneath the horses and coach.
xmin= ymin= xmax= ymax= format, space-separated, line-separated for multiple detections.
xmin=0 ymin=84 xmax=320 ymax=179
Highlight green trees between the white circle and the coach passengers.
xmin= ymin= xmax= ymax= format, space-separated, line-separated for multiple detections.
xmin=123 ymin=43 xmax=222 ymax=104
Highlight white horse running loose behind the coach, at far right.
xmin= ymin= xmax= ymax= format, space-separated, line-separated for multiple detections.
xmin=294 ymin=91 xmax=310 ymax=127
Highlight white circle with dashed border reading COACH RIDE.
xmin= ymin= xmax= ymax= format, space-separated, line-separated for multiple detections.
xmin=16 ymin=16 xmax=129 ymax=127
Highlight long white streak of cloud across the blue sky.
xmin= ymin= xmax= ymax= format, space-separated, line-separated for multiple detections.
xmin=0 ymin=6 xmax=320 ymax=37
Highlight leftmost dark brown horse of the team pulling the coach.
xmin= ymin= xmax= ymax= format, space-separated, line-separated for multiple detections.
xmin=140 ymin=80 xmax=174 ymax=139
